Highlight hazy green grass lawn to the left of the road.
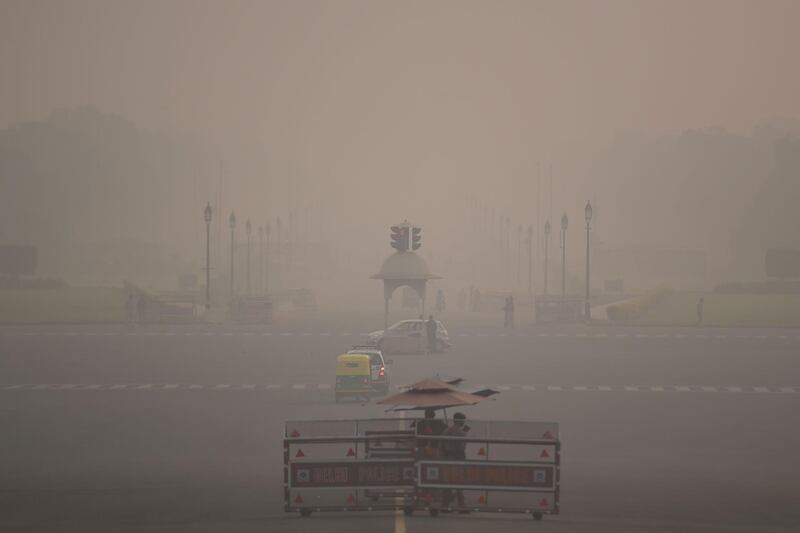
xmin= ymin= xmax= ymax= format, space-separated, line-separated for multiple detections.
xmin=0 ymin=287 xmax=127 ymax=323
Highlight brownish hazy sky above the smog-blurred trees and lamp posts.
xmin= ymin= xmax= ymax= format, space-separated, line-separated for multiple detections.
xmin=0 ymin=0 xmax=800 ymax=266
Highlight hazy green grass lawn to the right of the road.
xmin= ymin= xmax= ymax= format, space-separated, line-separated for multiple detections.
xmin=634 ymin=292 xmax=800 ymax=327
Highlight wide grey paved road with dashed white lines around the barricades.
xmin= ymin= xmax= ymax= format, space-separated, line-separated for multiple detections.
xmin=0 ymin=317 xmax=800 ymax=532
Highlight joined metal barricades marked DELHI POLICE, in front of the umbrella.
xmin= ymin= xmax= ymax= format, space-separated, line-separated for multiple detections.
xmin=284 ymin=418 xmax=561 ymax=519
